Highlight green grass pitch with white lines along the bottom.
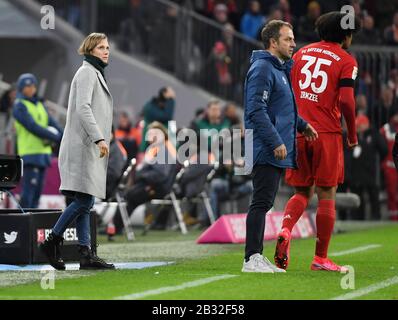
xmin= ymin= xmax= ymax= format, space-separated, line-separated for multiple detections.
xmin=0 ymin=224 xmax=398 ymax=300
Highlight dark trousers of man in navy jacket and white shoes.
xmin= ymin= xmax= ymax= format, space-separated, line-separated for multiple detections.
xmin=245 ymin=165 xmax=283 ymax=261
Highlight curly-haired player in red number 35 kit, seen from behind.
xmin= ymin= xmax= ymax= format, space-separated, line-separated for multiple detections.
xmin=275 ymin=12 xmax=359 ymax=271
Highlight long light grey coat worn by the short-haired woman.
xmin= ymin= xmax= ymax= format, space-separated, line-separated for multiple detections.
xmin=59 ymin=61 xmax=113 ymax=199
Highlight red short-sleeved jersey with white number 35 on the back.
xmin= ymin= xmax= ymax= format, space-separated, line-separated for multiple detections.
xmin=291 ymin=41 xmax=358 ymax=133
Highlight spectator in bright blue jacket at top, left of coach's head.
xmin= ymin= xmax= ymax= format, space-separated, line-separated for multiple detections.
xmin=240 ymin=0 xmax=265 ymax=39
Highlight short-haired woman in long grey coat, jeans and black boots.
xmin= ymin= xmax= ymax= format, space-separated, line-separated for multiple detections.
xmin=40 ymin=33 xmax=115 ymax=270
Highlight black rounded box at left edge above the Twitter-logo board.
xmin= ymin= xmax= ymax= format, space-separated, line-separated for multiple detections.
xmin=0 ymin=154 xmax=23 ymax=191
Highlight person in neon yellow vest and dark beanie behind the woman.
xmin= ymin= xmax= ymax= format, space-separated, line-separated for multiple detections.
xmin=13 ymin=73 xmax=63 ymax=208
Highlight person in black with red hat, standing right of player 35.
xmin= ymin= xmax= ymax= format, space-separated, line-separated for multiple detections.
xmin=348 ymin=114 xmax=388 ymax=220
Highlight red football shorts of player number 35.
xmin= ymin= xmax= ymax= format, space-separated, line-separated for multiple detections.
xmin=285 ymin=133 xmax=344 ymax=187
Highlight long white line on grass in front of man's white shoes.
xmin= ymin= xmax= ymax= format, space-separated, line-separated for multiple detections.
xmin=114 ymin=274 xmax=237 ymax=300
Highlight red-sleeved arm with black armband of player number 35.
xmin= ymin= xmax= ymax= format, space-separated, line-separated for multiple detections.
xmin=339 ymin=59 xmax=358 ymax=147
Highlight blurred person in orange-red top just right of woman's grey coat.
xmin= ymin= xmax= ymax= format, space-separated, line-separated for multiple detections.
xmin=115 ymin=111 xmax=142 ymax=159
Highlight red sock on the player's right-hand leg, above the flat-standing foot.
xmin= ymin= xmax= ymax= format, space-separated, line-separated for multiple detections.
xmin=315 ymin=200 xmax=336 ymax=258
